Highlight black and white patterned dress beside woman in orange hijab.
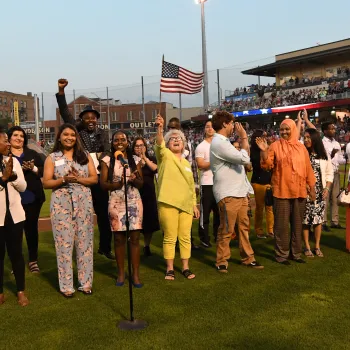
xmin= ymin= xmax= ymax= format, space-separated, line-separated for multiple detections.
xmin=303 ymin=154 xmax=326 ymax=225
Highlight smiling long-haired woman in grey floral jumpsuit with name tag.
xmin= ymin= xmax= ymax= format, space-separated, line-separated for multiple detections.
xmin=43 ymin=124 xmax=98 ymax=298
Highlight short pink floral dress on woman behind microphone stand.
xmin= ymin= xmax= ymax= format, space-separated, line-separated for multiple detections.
xmin=102 ymin=156 xmax=143 ymax=232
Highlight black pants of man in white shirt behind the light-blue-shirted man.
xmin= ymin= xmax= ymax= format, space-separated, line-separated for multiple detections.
xmin=198 ymin=185 xmax=220 ymax=244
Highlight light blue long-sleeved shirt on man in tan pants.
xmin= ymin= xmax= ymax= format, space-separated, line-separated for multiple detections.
xmin=210 ymin=134 xmax=254 ymax=203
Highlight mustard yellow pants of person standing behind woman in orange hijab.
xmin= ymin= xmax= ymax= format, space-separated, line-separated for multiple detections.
xmin=252 ymin=184 xmax=274 ymax=235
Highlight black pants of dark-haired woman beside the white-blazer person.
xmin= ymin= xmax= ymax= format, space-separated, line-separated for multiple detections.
xmin=23 ymin=201 xmax=43 ymax=261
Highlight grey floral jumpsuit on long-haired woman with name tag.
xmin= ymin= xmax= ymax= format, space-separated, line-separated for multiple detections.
xmin=50 ymin=152 xmax=94 ymax=293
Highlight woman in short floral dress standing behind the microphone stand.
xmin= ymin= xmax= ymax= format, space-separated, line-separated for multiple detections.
xmin=100 ymin=131 xmax=143 ymax=288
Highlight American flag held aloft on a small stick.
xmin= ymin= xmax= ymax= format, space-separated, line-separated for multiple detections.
xmin=160 ymin=61 xmax=204 ymax=94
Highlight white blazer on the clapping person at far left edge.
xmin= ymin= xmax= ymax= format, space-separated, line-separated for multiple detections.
xmin=0 ymin=157 xmax=27 ymax=226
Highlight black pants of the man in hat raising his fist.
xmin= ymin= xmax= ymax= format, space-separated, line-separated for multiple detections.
xmin=91 ymin=183 xmax=112 ymax=253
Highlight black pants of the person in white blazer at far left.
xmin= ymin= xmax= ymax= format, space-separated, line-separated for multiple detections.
xmin=0 ymin=212 xmax=25 ymax=294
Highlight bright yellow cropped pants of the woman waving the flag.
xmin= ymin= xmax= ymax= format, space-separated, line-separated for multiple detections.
xmin=158 ymin=203 xmax=192 ymax=259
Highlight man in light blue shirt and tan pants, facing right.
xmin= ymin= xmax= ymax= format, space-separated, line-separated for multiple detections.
xmin=210 ymin=111 xmax=263 ymax=273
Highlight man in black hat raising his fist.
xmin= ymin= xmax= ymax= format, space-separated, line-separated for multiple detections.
xmin=56 ymin=79 xmax=114 ymax=259
